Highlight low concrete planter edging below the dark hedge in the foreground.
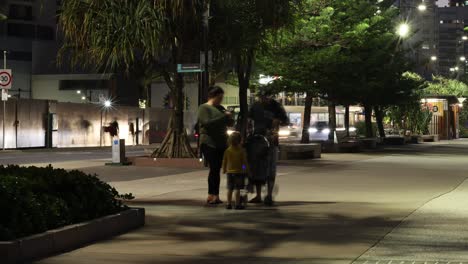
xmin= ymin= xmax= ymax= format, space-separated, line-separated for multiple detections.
xmin=0 ymin=208 xmax=145 ymax=264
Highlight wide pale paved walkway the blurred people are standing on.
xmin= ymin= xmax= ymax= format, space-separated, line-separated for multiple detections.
xmin=35 ymin=141 xmax=468 ymax=264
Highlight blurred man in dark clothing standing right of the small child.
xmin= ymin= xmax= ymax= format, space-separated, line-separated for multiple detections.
xmin=247 ymin=87 xmax=289 ymax=205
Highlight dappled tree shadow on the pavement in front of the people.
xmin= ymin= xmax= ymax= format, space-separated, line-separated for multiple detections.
xmin=119 ymin=200 xmax=399 ymax=263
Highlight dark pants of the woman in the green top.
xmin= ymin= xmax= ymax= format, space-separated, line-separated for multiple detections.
xmin=201 ymin=144 xmax=225 ymax=195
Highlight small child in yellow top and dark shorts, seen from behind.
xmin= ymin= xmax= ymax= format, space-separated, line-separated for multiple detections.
xmin=223 ymin=132 xmax=247 ymax=210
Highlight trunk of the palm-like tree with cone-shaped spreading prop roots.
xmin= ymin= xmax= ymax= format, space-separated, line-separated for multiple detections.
xmin=152 ymin=73 xmax=196 ymax=158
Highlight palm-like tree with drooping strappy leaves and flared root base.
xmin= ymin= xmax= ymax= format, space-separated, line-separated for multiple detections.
xmin=59 ymin=0 xmax=203 ymax=158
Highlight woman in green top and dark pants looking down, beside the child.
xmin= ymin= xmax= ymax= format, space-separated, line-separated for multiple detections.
xmin=198 ymin=86 xmax=233 ymax=204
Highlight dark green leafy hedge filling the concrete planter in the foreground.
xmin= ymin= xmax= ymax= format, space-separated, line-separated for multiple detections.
xmin=0 ymin=166 xmax=132 ymax=240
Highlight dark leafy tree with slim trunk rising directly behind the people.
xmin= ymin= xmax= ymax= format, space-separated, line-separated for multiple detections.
xmin=210 ymin=0 xmax=301 ymax=134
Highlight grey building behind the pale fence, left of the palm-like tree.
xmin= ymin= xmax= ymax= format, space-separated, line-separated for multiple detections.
xmin=0 ymin=0 xmax=116 ymax=105
